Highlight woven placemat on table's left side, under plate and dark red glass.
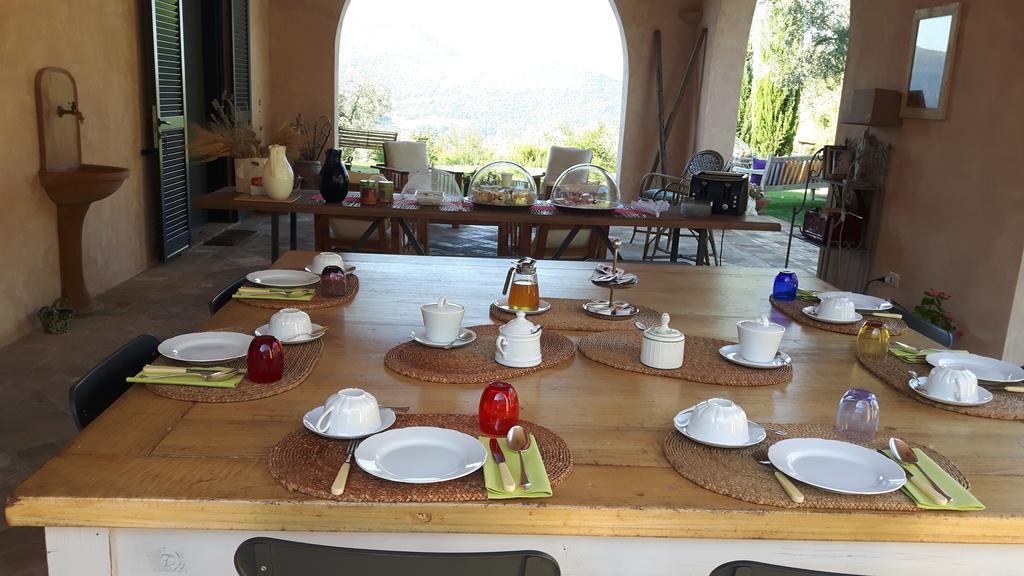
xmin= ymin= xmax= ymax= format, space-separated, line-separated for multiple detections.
xmin=145 ymin=339 xmax=324 ymax=402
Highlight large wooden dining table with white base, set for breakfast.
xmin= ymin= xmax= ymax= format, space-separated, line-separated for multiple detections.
xmin=5 ymin=251 xmax=1024 ymax=576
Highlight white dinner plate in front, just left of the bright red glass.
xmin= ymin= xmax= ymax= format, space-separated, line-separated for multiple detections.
xmin=355 ymin=426 xmax=487 ymax=484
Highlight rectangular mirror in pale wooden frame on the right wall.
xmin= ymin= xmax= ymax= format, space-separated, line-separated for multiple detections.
xmin=900 ymin=3 xmax=959 ymax=120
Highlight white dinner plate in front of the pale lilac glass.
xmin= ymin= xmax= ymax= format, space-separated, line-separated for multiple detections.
xmin=768 ymin=438 xmax=906 ymax=494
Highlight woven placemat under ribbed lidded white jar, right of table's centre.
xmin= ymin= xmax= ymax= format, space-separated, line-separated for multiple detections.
xmin=580 ymin=330 xmax=793 ymax=386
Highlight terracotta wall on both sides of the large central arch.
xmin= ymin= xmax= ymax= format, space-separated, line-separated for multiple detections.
xmin=269 ymin=0 xmax=708 ymax=198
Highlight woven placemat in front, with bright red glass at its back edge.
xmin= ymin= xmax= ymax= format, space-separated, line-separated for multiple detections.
xmin=267 ymin=414 xmax=572 ymax=502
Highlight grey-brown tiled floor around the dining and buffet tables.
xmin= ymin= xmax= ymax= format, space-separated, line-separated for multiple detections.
xmin=0 ymin=213 xmax=817 ymax=576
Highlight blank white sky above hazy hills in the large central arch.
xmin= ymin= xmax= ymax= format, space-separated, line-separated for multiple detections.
xmin=339 ymin=0 xmax=623 ymax=81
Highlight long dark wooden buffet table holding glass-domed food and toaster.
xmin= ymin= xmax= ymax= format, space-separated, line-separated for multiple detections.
xmin=191 ymin=187 xmax=782 ymax=260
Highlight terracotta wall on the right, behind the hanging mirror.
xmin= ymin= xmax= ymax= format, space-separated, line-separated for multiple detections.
xmin=838 ymin=0 xmax=1024 ymax=362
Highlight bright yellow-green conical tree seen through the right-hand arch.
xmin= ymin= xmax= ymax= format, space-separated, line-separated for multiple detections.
xmin=750 ymin=78 xmax=800 ymax=158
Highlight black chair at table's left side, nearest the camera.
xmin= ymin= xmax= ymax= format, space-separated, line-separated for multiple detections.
xmin=68 ymin=334 xmax=160 ymax=429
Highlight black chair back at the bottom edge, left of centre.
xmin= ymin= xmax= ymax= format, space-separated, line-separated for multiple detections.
xmin=234 ymin=538 xmax=561 ymax=576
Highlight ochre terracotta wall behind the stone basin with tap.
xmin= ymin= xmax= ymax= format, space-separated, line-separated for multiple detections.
xmin=0 ymin=0 xmax=154 ymax=345
